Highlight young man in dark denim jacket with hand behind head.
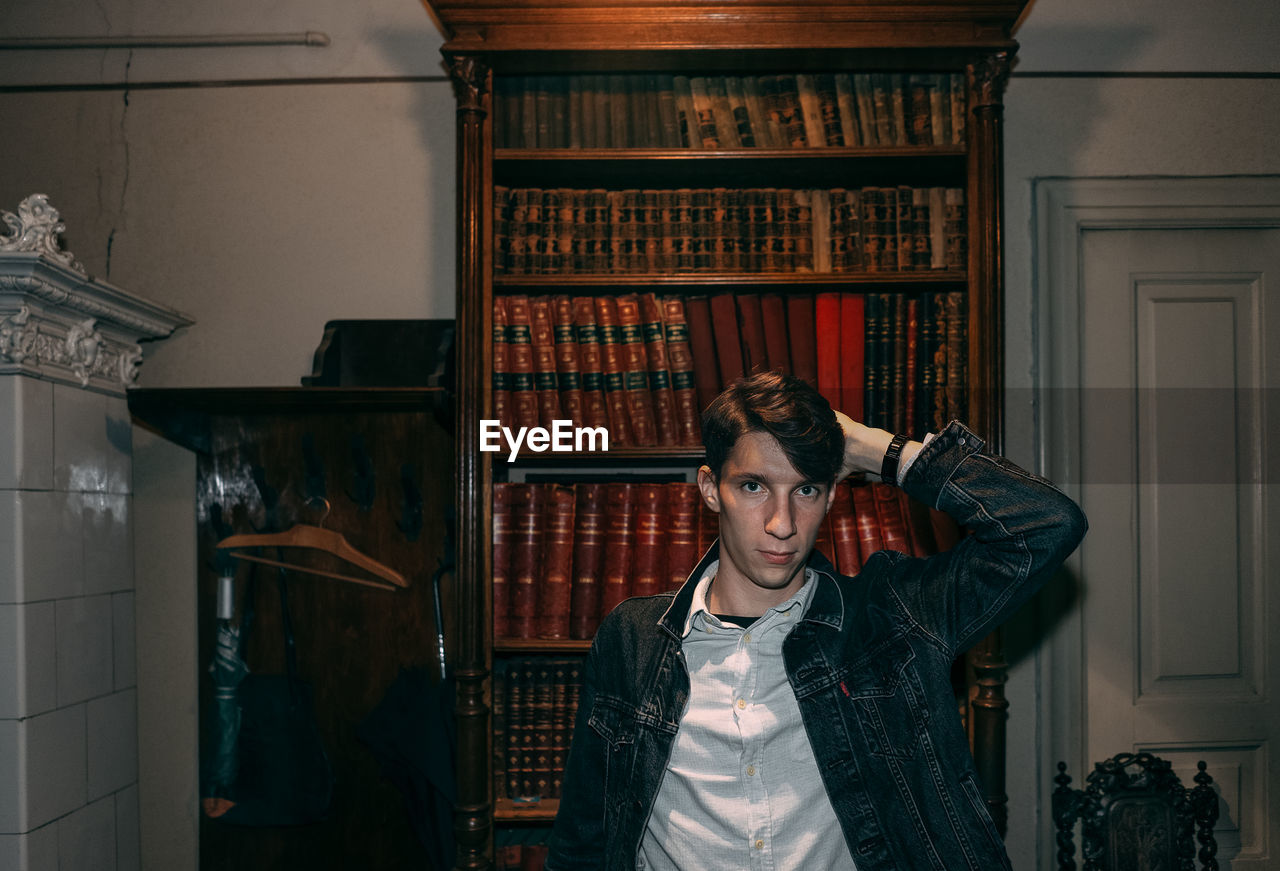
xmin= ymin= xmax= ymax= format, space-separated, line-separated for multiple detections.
xmin=545 ymin=374 xmax=1085 ymax=871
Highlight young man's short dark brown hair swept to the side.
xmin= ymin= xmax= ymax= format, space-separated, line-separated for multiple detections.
xmin=703 ymin=371 xmax=845 ymax=484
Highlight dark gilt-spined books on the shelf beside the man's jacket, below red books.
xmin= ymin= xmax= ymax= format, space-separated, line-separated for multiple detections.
xmin=493 ymin=656 xmax=582 ymax=802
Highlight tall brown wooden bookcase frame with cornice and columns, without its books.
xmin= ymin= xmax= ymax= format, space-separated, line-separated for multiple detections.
xmin=425 ymin=0 xmax=1025 ymax=868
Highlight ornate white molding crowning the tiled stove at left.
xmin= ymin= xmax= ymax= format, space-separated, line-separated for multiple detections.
xmin=0 ymin=193 xmax=193 ymax=395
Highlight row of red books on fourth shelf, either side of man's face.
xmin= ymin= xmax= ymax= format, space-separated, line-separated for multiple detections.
xmin=493 ymin=480 xmax=955 ymax=639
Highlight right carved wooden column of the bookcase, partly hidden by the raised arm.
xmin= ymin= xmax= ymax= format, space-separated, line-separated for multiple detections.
xmin=966 ymin=51 xmax=1012 ymax=835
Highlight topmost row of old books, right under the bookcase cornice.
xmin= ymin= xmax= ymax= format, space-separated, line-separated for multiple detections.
xmin=494 ymin=73 xmax=965 ymax=150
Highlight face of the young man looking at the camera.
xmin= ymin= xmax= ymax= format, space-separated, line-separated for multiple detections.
xmin=698 ymin=432 xmax=835 ymax=602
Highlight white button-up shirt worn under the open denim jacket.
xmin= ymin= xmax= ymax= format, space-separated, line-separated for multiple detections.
xmin=636 ymin=562 xmax=856 ymax=871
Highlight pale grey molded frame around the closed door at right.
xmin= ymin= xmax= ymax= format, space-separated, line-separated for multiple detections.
xmin=1032 ymin=175 xmax=1280 ymax=868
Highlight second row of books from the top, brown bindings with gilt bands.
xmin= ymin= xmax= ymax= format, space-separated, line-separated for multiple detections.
xmin=493 ymin=184 xmax=968 ymax=275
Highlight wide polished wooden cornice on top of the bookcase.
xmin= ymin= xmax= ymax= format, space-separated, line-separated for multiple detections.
xmin=424 ymin=0 xmax=1027 ymax=56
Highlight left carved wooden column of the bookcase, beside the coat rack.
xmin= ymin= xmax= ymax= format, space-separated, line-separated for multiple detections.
xmin=449 ymin=55 xmax=493 ymax=871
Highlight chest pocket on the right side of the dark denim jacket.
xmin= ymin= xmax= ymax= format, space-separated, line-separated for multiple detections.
xmin=840 ymin=635 xmax=928 ymax=758
